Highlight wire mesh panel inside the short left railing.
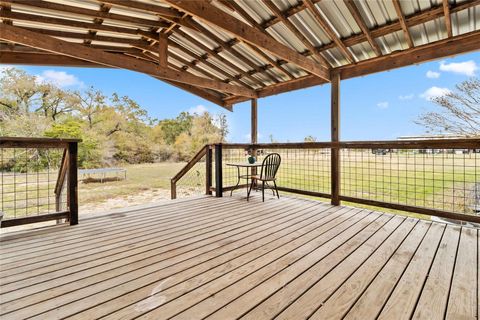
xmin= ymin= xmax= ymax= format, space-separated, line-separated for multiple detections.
xmin=0 ymin=148 xmax=67 ymax=219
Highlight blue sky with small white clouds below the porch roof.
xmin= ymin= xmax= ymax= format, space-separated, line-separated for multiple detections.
xmin=1 ymin=52 xmax=480 ymax=142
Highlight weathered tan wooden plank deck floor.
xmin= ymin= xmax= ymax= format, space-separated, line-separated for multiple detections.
xmin=0 ymin=196 xmax=480 ymax=320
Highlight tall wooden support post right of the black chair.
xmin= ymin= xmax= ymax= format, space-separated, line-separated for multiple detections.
xmin=331 ymin=73 xmax=340 ymax=206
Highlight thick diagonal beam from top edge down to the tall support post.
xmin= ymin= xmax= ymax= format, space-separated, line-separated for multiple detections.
xmin=161 ymin=0 xmax=330 ymax=80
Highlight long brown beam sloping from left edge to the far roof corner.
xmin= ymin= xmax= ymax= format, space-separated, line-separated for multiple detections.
xmin=0 ymin=25 xmax=256 ymax=97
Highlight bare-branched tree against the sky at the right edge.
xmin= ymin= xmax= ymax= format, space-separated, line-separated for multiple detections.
xmin=415 ymin=78 xmax=480 ymax=136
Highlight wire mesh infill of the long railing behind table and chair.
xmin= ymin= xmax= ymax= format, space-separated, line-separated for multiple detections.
xmin=172 ymin=141 xmax=480 ymax=220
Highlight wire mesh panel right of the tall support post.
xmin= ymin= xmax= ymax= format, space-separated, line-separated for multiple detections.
xmin=341 ymin=149 xmax=480 ymax=214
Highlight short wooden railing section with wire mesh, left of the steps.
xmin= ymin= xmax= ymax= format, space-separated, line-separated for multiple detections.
xmin=0 ymin=137 xmax=80 ymax=227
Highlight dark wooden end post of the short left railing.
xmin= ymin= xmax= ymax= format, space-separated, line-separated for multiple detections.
xmin=67 ymin=142 xmax=78 ymax=225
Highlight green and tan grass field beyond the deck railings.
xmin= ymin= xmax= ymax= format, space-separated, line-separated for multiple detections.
xmin=1 ymin=151 xmax=480 ymax=217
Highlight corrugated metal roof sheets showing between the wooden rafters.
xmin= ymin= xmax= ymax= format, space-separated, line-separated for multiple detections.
xmin=2 ymin=0 xmax=480 ymax=102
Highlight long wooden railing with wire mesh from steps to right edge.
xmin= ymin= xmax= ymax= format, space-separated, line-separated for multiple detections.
xmin=172 ymin=139 xmax=480 ymax=223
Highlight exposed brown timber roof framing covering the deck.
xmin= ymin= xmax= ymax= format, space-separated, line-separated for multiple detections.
xmin=0 ymin=0 xmax=480 ymax=106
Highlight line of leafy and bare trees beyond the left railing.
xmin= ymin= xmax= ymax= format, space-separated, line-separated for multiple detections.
xmin=0 ymin=68 xmax=228 ymax=168
